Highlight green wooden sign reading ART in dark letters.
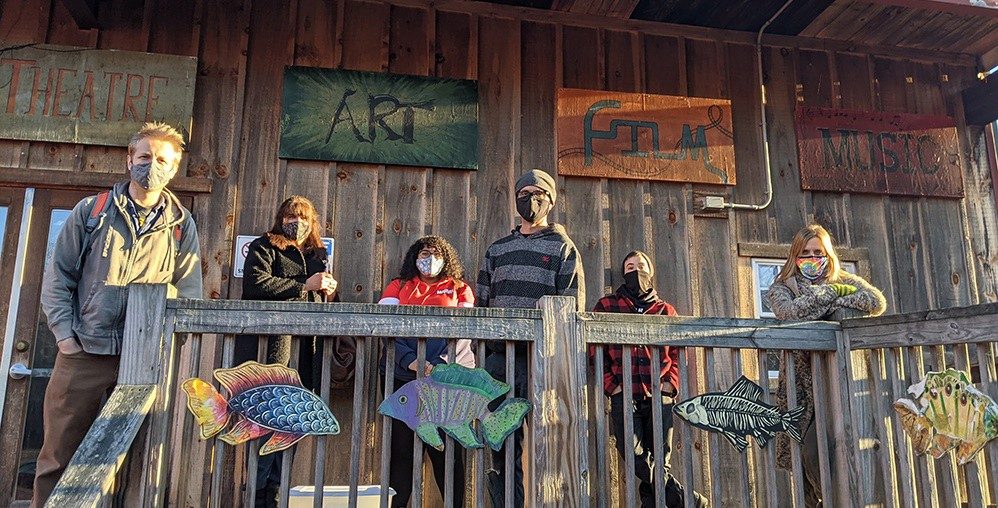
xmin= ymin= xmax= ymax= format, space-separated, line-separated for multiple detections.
xmin=280 ymin=67 xmax=478 ymax=169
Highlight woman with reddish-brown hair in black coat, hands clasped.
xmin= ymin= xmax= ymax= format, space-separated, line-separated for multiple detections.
xmin=234 ymin=196 xmax=355 ymax=506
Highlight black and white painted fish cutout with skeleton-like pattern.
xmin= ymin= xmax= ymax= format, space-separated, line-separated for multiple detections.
xmin=672 ymin=376 xmax=805 ymax=452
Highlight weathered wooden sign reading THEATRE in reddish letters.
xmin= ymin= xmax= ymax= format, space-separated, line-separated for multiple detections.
xmin=0 ymin=45 xmax=197 ymax=146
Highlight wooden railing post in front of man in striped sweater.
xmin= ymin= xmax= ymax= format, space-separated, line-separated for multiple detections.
xmin=528 ymin=296 xmax=588 ymax=506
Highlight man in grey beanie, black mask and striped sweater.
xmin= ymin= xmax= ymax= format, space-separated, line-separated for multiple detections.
xmin=475 ymin=169 xmax=586 ymax=507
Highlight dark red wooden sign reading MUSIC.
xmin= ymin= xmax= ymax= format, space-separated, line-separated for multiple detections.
xmin=796 ymin=107 xmax=963 ymax=198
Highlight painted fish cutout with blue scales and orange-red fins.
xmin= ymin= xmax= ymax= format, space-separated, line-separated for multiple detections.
xmin=182 ymin=361 xmax=340 ymax=455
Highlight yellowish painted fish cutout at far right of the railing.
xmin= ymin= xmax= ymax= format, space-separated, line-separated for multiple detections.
xmin=894 ymin=369 xmax=998 ymax=465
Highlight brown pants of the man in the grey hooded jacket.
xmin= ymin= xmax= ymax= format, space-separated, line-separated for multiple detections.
xmin=31 ymin=353 xmax=121 ymax=508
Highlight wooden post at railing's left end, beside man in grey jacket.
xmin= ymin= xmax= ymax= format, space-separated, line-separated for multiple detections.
xmin=118 ymin=284 xmax=179 ymax=506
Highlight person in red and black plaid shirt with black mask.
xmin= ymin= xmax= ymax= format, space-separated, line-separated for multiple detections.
xmin=589 ymin=251 xmax=707 ymax=508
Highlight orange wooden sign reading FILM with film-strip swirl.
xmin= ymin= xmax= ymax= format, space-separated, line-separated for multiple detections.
xmin=556 ymin=88 xmax=735 ymax=185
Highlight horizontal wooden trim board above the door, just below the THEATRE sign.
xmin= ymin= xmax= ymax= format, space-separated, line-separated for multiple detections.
xmin=0 ymin=170 xmax=211 ymax=194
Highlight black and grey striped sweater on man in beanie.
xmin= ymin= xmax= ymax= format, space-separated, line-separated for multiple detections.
xmin=475 ymin=224 xmax=586 ymax=352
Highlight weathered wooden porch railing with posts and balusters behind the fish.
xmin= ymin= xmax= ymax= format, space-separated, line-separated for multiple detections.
xmin=49 ymin=285 xmax=998 ymax=507
